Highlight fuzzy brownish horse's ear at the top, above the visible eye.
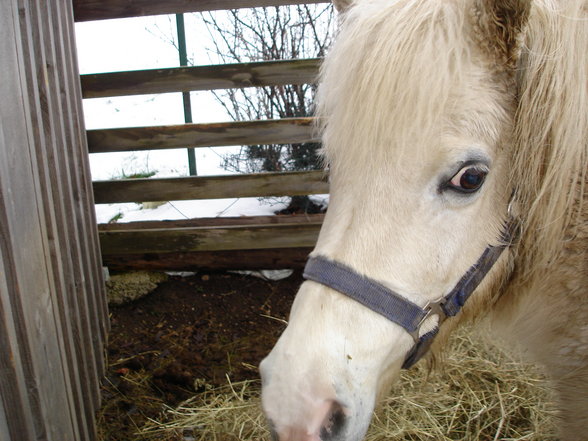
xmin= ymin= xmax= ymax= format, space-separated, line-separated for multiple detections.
xmin=474 ymin=0 xmax=532 ymax=66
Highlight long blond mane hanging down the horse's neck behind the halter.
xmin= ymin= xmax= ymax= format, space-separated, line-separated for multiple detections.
xmin=511 ymin=0 xmax=588 ymax=280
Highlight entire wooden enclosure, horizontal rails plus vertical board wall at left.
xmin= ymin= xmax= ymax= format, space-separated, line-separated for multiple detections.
xmin=0 ymin=0 xmax=328 ymax=441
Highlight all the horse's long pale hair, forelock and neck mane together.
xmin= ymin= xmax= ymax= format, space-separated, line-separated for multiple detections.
xmin=317 ymin=0 xmax=588 ymax=279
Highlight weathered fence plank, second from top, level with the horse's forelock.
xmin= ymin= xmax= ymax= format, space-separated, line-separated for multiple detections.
xmin=80 ymin=58 xmax=321 ymax=98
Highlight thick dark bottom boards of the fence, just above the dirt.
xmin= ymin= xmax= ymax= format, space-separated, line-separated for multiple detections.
xmin=99 ymin=214 xmax=324 ymax=271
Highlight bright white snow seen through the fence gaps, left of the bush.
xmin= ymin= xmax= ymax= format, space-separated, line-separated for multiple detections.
xmin=76 ymin=14 xmax=327 ymax=223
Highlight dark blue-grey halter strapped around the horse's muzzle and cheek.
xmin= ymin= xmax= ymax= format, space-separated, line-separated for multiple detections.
xmin=303 ymin=222 xmax=514 ymax=369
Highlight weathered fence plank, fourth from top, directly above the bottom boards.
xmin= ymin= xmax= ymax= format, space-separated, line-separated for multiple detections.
xmin=93 ymin=171 xmax=328 ymax=204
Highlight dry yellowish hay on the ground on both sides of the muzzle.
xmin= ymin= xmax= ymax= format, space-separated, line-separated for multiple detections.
xmin=141 ymin=329 xmax=555 ymax=441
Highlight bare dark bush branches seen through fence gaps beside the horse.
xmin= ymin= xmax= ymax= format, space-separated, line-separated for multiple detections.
xmin=195 ymin=4 xmax=335 ymax=176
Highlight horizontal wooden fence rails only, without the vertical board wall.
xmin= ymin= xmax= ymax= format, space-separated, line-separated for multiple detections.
xmin=73 ymin=0 xmax=328 ymax=270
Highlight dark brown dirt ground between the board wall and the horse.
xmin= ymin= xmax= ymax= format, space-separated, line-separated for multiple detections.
xmin=98 ymin=272 xmax=302 ymax=441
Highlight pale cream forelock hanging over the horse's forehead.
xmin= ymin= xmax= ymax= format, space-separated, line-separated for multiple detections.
xmin=317 ymin=1 xmax=469 ymax=163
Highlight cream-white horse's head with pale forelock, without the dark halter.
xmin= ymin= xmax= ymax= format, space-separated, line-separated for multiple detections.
xmin=261 ymin=0 xmax=529 ymax=441
